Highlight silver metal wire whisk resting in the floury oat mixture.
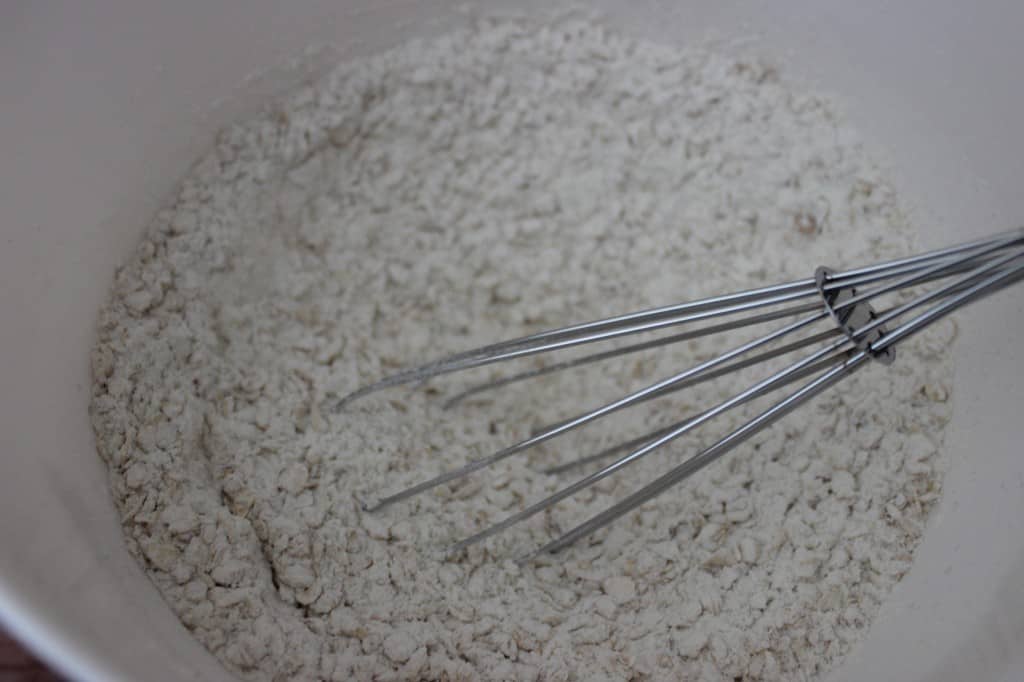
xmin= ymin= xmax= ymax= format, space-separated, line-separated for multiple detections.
xmin=339 ymin=228 xmax=1024 ymax=561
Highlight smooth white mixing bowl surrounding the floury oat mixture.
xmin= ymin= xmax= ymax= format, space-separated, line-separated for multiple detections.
xmin=0 ymin=0 xmax=1024 ymax=682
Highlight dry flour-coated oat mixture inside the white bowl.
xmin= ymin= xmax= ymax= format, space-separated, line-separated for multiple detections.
xmin=92 ymin=15 xmax=954 ymax=681
